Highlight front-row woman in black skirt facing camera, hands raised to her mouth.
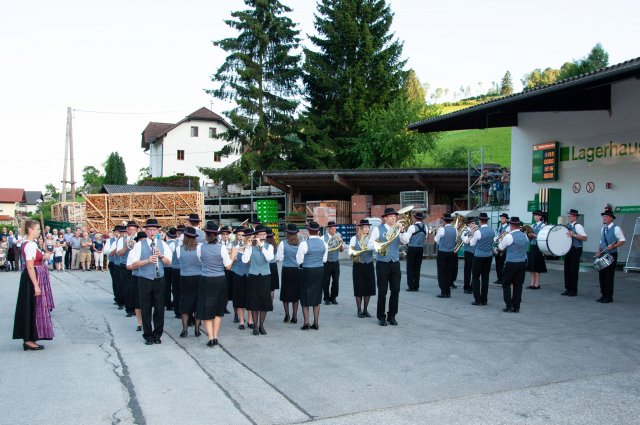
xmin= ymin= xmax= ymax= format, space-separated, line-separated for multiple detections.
xmin=242 ymin=225 xmax=275 ymax=335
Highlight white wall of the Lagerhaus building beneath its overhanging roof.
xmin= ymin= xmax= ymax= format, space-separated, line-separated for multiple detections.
xmin=510 ymin=80 xmax=640 ymax=251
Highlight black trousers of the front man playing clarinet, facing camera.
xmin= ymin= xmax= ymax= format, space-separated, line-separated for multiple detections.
xmin=138 ymin=276 xmax=165 ymax=341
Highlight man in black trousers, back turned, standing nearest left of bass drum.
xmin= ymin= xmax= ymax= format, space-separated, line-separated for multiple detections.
xmin=498 ymin=217 xmax=529 ymax=313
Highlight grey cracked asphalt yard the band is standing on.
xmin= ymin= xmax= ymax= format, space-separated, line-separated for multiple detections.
xmin=0 ymin=260 xmax=640 ymax=425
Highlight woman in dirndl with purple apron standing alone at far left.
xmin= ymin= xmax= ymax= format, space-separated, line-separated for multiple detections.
xmin=13 ymin=220 xmax=54 ymax=351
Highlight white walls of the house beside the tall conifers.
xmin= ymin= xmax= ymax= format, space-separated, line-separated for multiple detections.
xmin=150 ymin=121 xmax=239 ymax=183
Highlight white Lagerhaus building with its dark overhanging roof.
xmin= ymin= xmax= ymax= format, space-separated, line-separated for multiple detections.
xmin=409 ymin=58 xmax=640 ymax=261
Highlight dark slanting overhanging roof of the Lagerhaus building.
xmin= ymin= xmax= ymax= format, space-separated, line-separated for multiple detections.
xmin=409 ymin=58 xmax=640 ymax=133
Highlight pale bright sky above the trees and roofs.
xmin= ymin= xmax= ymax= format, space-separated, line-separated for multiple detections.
xmin=0 ymin=0 xmax=640 ymax=190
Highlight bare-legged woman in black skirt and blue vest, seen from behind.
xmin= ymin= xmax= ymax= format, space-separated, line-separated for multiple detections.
xmin=196 ymin=221 xmax=231 ymax=347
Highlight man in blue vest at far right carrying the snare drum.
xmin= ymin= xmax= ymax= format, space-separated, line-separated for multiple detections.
xmin=594 ymin=209 xmax=626 ymax=304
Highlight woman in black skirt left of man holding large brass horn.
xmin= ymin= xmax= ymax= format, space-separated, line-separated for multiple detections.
xmin=349 ymin=219 xmax=376 ymax=318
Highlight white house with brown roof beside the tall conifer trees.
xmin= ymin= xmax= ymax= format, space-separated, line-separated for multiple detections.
xmin=142 ymin=108 xmax=240 ymax=181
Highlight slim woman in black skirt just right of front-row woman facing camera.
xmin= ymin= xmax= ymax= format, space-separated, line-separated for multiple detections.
xmin=276 ymin=223 xmax=301 ymax=323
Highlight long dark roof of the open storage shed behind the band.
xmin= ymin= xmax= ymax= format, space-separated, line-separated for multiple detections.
xmin=262 ymin=168 xmax=467 ymax=199
